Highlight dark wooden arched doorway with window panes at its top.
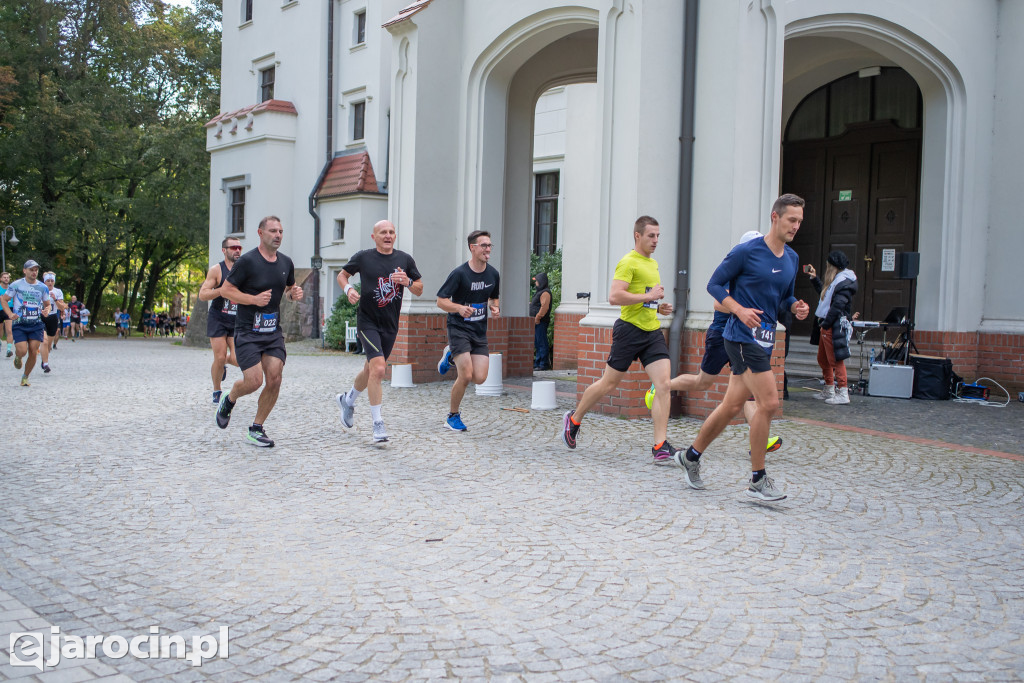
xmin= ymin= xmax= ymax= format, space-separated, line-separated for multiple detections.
xmin=782 ymin=67 xmax=923 ymax=335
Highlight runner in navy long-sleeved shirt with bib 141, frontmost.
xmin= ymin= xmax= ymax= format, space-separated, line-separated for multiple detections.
xmin=676 ymin=195 xmax=810 ymax=501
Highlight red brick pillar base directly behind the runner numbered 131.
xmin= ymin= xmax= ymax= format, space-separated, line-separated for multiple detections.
xmin=387 ymin=313 xmax=534 ymax=383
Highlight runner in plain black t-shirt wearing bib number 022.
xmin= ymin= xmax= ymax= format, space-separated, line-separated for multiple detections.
xmin=210 ymin=216 xmax=302 ymax=446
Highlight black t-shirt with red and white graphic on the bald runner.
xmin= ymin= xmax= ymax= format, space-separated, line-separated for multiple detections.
xmin=344 ymin=248 xmax=423 ymax=332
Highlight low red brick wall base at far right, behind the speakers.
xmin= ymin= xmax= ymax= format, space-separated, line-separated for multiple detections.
xmin=913 ymin=330 xmax=1024 ymax=397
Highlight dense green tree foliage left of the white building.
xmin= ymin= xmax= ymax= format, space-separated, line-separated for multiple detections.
xmin=0 ymin=0 xmax=220 ymax=319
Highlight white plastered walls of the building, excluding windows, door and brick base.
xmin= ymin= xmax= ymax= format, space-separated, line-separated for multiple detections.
xmin=209 ymin=0 xmax=1024 ymax=331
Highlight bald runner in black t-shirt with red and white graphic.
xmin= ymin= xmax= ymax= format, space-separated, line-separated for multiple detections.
xmin=335 ymin=220 xmax=423 ymax=442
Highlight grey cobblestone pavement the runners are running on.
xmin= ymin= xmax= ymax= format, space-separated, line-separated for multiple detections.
xmin=0 ymin=340 xmax=1024 ymax=681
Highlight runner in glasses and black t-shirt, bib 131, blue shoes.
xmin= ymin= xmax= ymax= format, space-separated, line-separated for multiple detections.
xmin=437 ymin=230 xmax=500 ymax=432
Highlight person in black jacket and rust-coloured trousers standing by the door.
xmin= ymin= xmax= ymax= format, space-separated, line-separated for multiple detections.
xmin=804 ymin=250 xmax=857 ymax=405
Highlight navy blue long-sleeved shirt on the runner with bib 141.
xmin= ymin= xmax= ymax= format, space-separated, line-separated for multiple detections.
xmin=708 ymin=239 xmax=800 ymax=349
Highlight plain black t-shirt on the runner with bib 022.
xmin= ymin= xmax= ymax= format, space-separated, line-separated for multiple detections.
xmin=227 ymin=248 xmax=295 ymax=334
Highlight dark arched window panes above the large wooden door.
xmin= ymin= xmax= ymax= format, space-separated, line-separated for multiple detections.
xmin=785 ymin=67 xmax=922 ymax=142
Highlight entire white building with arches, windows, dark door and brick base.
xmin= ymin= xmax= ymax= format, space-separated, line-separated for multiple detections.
xmin=207 ymin=0 xmax=1024 ymax=415
